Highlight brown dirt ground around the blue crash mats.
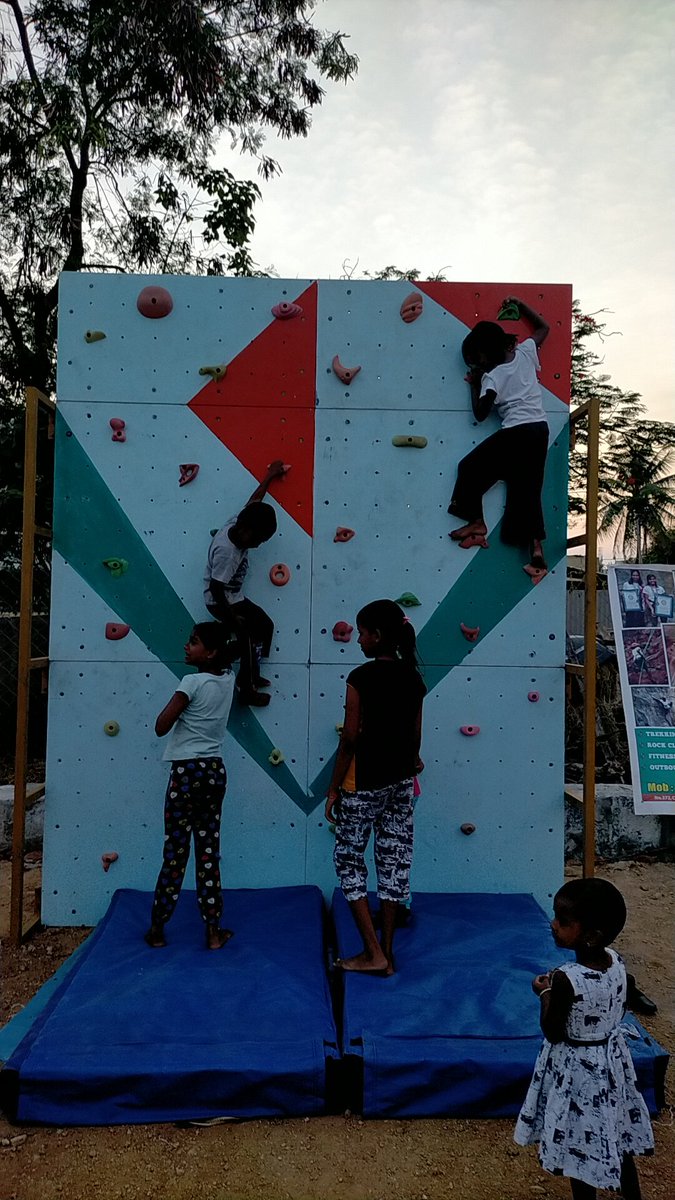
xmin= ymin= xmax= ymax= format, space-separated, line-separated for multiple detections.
xmin=0 ymin=862 xmax=675 ymax=1200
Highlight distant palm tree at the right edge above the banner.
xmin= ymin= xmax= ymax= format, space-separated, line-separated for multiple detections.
xmin=599 ymin=436 xmax=675 ymax=563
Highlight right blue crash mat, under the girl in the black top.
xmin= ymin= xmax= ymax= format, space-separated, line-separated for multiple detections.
xmin=333 ymin=890 xmax=668 ymax=1117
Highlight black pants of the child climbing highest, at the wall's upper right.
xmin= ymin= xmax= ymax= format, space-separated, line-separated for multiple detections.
xmin=448 ymin=421 xmax=549 ymax=546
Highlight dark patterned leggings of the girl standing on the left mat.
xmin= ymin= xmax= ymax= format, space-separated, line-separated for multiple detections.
xmin=151 ymin=757 xmax=227 ymax=925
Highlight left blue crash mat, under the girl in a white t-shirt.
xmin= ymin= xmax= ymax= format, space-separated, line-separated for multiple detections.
xmin=0 ymin=887 xmax=338 ymax=1126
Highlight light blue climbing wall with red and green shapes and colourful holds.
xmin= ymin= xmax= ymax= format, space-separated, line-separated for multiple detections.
xmin=43 ymin=275 xmax=572 ymax=924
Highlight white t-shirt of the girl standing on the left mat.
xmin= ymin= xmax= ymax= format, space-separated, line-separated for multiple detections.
xmin=162 ymin=671 xmax=234 ymax=762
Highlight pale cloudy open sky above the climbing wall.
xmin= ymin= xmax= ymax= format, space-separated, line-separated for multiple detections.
xmin=239 ymin=0 xmax=675 ymax=420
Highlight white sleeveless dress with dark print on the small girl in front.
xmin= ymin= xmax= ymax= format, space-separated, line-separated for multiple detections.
xmin=514 ymin=950 xmax=653 ymax=1190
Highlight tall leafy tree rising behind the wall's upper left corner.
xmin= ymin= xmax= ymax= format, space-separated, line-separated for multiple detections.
xmin=0 ymin=0 xmax=357 ymax=395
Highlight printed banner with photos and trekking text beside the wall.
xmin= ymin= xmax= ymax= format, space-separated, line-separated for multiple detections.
xmin=608 ymin=563 xmax=675 ymax=814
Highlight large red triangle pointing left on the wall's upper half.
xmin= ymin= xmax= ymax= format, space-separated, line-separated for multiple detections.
xmin=187 ymin=283 xmax=317 ymax=536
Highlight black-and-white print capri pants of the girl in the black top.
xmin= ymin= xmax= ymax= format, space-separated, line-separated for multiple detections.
xmin=333 ymin=778 xmax=413 ymax=904
